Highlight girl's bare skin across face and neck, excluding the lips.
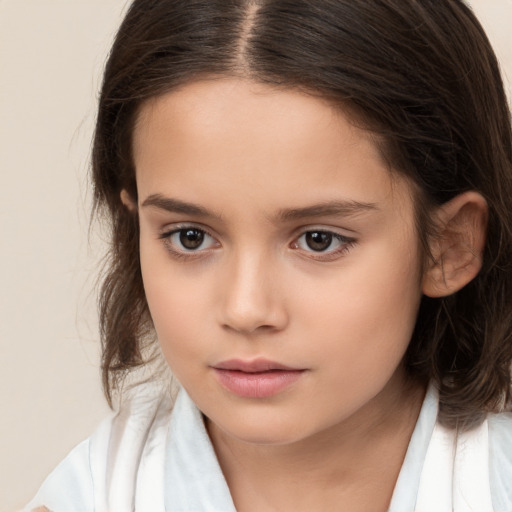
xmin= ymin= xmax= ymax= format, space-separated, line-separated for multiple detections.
xmin=130 ymin=78 xmax=442 ymax=512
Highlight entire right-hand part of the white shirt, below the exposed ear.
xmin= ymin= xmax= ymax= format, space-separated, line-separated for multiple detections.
xmin=398 ymin=388 xmax=512 ymax=512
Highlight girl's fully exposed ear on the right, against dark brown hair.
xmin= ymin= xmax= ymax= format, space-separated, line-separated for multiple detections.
xmin=423 ymin=191 xmax=488 ymax=297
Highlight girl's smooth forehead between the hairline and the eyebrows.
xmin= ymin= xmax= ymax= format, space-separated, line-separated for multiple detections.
xmin=134 ymin=79 xmax=412 ymax=219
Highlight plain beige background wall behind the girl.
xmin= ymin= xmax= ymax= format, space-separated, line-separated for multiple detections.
xmin=0 ymin=0 xmax=512 ymax=512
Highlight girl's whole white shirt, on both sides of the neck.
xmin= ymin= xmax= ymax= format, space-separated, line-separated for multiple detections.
xmin=24 ymin=386 xmax=512 ymax=512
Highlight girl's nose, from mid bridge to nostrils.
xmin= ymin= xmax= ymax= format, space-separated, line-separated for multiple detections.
xmin=220 ymin=254 xmax=288 ymax=334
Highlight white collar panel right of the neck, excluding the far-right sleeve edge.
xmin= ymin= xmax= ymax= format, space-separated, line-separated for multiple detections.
xmin=389 ymin=385 xmax=494 ymax=512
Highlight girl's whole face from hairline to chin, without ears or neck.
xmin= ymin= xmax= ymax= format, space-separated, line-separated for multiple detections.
xmin=134 ymin=79 xmax=422 ymax=443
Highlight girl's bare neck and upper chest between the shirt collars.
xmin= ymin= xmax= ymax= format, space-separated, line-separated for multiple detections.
xmin=208 ymin=375 xmax=425 ymax=512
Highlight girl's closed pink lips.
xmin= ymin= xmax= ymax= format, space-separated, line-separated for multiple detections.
xmin=212 ymin=359 xmax=305 ymax=398
